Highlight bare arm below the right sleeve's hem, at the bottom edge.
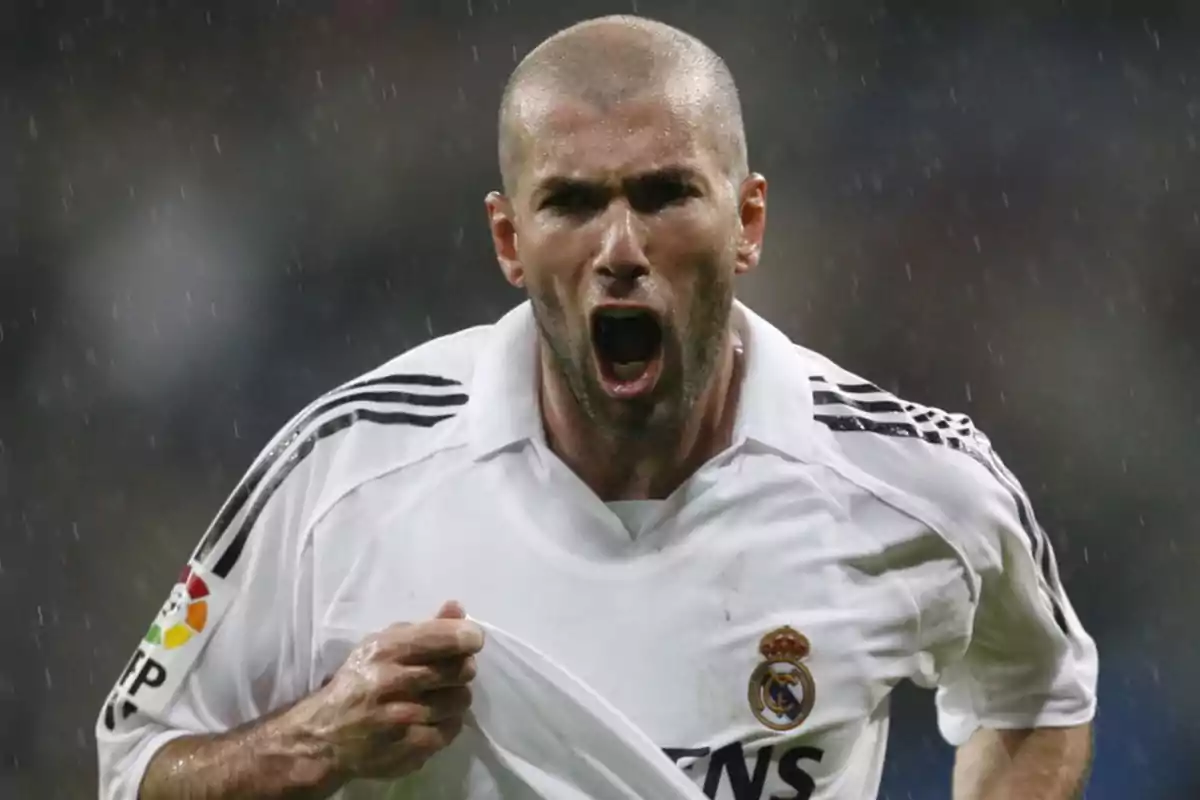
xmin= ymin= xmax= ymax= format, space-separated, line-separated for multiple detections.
xmin=954 ymin=724 xmax=1092 ymax=800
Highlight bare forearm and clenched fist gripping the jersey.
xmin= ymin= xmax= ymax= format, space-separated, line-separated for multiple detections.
xmin=129 ymin=602 xmax=484 ymax=800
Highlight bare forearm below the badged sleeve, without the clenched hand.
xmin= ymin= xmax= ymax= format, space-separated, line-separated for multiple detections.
xmin=138 ymin=700 xmax=342 ymax=800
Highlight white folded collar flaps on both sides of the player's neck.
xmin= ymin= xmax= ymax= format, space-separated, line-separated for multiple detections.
xmin=466 ymin=301 xmax=812 ymax=461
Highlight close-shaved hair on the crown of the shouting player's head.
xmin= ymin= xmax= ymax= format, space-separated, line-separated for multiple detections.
xmin=499 ymin=14 xmax=749 ymax=194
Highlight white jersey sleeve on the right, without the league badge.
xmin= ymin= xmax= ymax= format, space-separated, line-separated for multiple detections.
xmin=936 ymin=432 xmax=1097 ymax=746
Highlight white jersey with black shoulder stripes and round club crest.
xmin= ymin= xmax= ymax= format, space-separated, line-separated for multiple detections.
xmin=97 ymin=303 xmax=1097 ymax=800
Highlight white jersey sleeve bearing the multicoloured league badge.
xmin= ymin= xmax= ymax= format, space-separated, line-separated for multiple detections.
xmin=96 ymin=438 xmax=312 ymax=800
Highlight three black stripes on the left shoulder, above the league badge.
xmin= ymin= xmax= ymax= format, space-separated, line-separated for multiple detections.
xmin=192 ymin=374 xmax=467 ymax=578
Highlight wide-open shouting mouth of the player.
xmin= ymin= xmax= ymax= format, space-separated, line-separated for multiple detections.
xmin=592 ymin=307 xmax=662 ymax=397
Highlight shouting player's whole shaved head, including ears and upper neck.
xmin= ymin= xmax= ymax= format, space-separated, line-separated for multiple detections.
xmin=485 ymin=16 xmax=767 ymax=472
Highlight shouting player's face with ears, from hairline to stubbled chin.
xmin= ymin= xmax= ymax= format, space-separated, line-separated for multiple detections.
xmin=488 ymin=94 xmax=766 ymax=435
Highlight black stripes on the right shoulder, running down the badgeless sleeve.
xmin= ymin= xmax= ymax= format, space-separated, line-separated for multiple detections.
xmin=810 ymin=375 xmax=1070 ymax=633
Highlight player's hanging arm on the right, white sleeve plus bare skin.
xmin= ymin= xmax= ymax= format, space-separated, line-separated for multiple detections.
xmin=937 ymin=434 xmax=1097 ymax=800
